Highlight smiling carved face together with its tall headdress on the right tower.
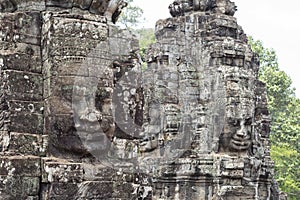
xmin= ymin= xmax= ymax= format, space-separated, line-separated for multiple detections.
xmin=220 ymin=76 xmax=255 ymax=153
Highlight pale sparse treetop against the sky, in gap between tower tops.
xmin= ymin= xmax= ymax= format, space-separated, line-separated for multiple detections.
xmin=118 ymin=0 xmax=144 ymax=29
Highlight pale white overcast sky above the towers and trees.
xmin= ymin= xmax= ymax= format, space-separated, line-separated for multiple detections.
xmin=134 ymin=0 xmax=300 ymax=98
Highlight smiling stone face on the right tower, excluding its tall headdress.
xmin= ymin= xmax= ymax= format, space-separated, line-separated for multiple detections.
xmin=221 ymin=118 xmax=252 ymax=152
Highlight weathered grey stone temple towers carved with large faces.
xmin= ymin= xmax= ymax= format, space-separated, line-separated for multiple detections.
xmin=0 ymin=0 xmax=284 ymax=200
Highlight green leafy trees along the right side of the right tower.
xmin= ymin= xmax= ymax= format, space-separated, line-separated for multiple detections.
xmin=249 ymin=37 xmax=300 ymax=200
